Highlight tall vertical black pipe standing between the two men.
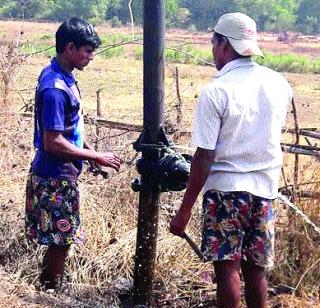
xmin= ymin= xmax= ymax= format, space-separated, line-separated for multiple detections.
xmin=134 ymin=0 xmax=165 ymax=306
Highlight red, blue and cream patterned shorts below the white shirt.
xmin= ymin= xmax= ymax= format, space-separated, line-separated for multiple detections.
xmin=201 ymin=190 xmax=275 ymax=268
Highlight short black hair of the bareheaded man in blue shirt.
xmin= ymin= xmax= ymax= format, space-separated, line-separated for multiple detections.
xmin=56 ymin=17 xmax=101 ymax=53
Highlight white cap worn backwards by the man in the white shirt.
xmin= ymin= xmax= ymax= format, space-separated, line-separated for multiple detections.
xmin=214 ymin=13 xmax=263 ymax=57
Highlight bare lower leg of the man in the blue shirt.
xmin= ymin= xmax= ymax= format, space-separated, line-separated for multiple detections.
xmin=40 ymin=245 xmax=70 ymax=290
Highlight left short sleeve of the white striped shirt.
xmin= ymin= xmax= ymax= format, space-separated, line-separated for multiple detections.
xmin=192 ymin=88 xmax=223 ymax=150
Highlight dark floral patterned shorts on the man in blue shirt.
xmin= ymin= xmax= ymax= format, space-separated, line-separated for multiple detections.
xmin=25 ymin=173 xmax=84 ymax=245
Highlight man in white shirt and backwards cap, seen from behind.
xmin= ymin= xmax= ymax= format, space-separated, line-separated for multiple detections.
xmin=170 ymin=13 xmax=293 ymax=308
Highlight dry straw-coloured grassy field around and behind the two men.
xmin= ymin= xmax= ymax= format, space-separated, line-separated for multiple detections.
xmin=0 ymin=21 xmax=320 ymax=307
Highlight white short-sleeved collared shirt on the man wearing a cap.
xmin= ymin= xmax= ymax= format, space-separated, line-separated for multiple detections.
xmin=192 ymin=58 xmax=293 ymax=199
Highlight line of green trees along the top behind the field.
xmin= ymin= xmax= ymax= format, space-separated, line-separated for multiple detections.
xmin=0 ymin=0 xmax=320 ymax=34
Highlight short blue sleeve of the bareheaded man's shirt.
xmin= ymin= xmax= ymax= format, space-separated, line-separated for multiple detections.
xmin=42 ymin=89 xmax=67 ymax=131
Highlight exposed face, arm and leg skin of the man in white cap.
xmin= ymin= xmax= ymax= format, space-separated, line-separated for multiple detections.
xmin=170 ymin=32 xmax=267 ymax=308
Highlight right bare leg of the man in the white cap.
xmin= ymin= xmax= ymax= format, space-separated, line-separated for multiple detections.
xmin=241 ymin=261 xmax=268 ymax=308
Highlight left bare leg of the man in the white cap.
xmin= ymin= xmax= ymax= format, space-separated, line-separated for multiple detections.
xmin=214 ymin=261 xmax=241 ymax=308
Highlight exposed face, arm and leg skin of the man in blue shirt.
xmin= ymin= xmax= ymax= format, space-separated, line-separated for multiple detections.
xmin=40 ymin=43 xmax=120 ymax=289
